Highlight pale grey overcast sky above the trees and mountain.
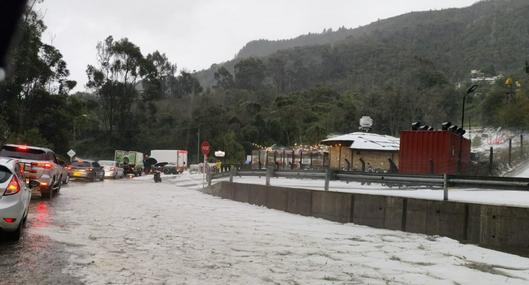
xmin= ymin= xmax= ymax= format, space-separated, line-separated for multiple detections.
xmin=39 ymin=0 xmax=477 ymax=90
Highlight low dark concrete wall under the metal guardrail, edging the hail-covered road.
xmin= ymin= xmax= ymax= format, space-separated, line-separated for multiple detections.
xmin=204 ymin=182 xmax=529 ymax=255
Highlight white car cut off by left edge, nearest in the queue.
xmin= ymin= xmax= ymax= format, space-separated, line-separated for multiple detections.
xmin=0 ymin=158 xmax=33 ymax=241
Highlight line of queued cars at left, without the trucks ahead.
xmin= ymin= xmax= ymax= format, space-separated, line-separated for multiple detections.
xmin=0 ymin=144 xmax=124 ymax=241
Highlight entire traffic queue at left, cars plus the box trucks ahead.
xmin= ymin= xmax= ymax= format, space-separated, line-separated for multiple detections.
xmin=0 ymin=144 xmax=187 ymax=241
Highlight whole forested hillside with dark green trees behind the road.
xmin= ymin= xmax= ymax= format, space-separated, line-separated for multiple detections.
xmin=0 ymin=0 xmax=529 ymax=163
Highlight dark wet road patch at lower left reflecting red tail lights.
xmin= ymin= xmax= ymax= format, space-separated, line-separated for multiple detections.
xmin=0 ymin=185 xmax=82 ymax=284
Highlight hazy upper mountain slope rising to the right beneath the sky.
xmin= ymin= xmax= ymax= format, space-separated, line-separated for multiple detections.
xmin=196 ymin=0 xmax=529 ymax=91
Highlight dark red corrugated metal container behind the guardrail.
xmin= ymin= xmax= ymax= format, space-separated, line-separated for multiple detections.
xmin=399 ymin=131 xmax=470 ymax=174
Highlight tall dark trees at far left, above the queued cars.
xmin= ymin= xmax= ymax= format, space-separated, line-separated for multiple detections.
xmin=0 ymin=1 xmax=76 ymax=152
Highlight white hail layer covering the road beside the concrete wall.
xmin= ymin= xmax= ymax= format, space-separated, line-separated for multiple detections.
xmin=14 ymin=174 xmax=529 ymax=284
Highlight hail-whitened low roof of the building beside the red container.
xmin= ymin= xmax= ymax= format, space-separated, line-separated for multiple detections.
xmin=321 ymin=132 xmax=400 ymax=151
